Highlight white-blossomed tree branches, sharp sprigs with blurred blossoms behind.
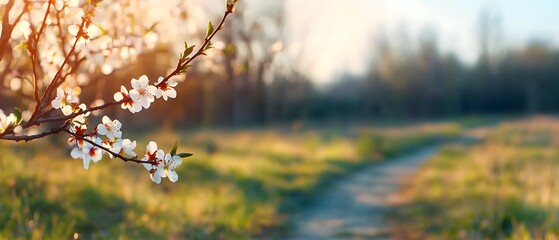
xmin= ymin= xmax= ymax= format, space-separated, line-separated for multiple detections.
xmin=0 ymin=0 xmax=237 ymax=183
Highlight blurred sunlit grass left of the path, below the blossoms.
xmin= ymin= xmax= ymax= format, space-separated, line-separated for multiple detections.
xmin=0 ymin=123 xmax=461 ymax=239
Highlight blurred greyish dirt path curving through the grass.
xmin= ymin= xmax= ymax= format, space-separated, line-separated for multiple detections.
xmin=289 ymin=147 xmax=439 ymax=240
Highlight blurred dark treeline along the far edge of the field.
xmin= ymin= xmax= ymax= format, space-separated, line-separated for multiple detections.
xmin=164 ymin=39 xmax=559 ymax=125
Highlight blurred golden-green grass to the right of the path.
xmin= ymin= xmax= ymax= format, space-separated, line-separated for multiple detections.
xmin=389 ymin=117 xmax=559 ymax=239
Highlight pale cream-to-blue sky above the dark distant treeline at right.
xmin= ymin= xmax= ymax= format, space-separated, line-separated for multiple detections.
xmin=287 ymin=0 xmax=559 ymax=81
